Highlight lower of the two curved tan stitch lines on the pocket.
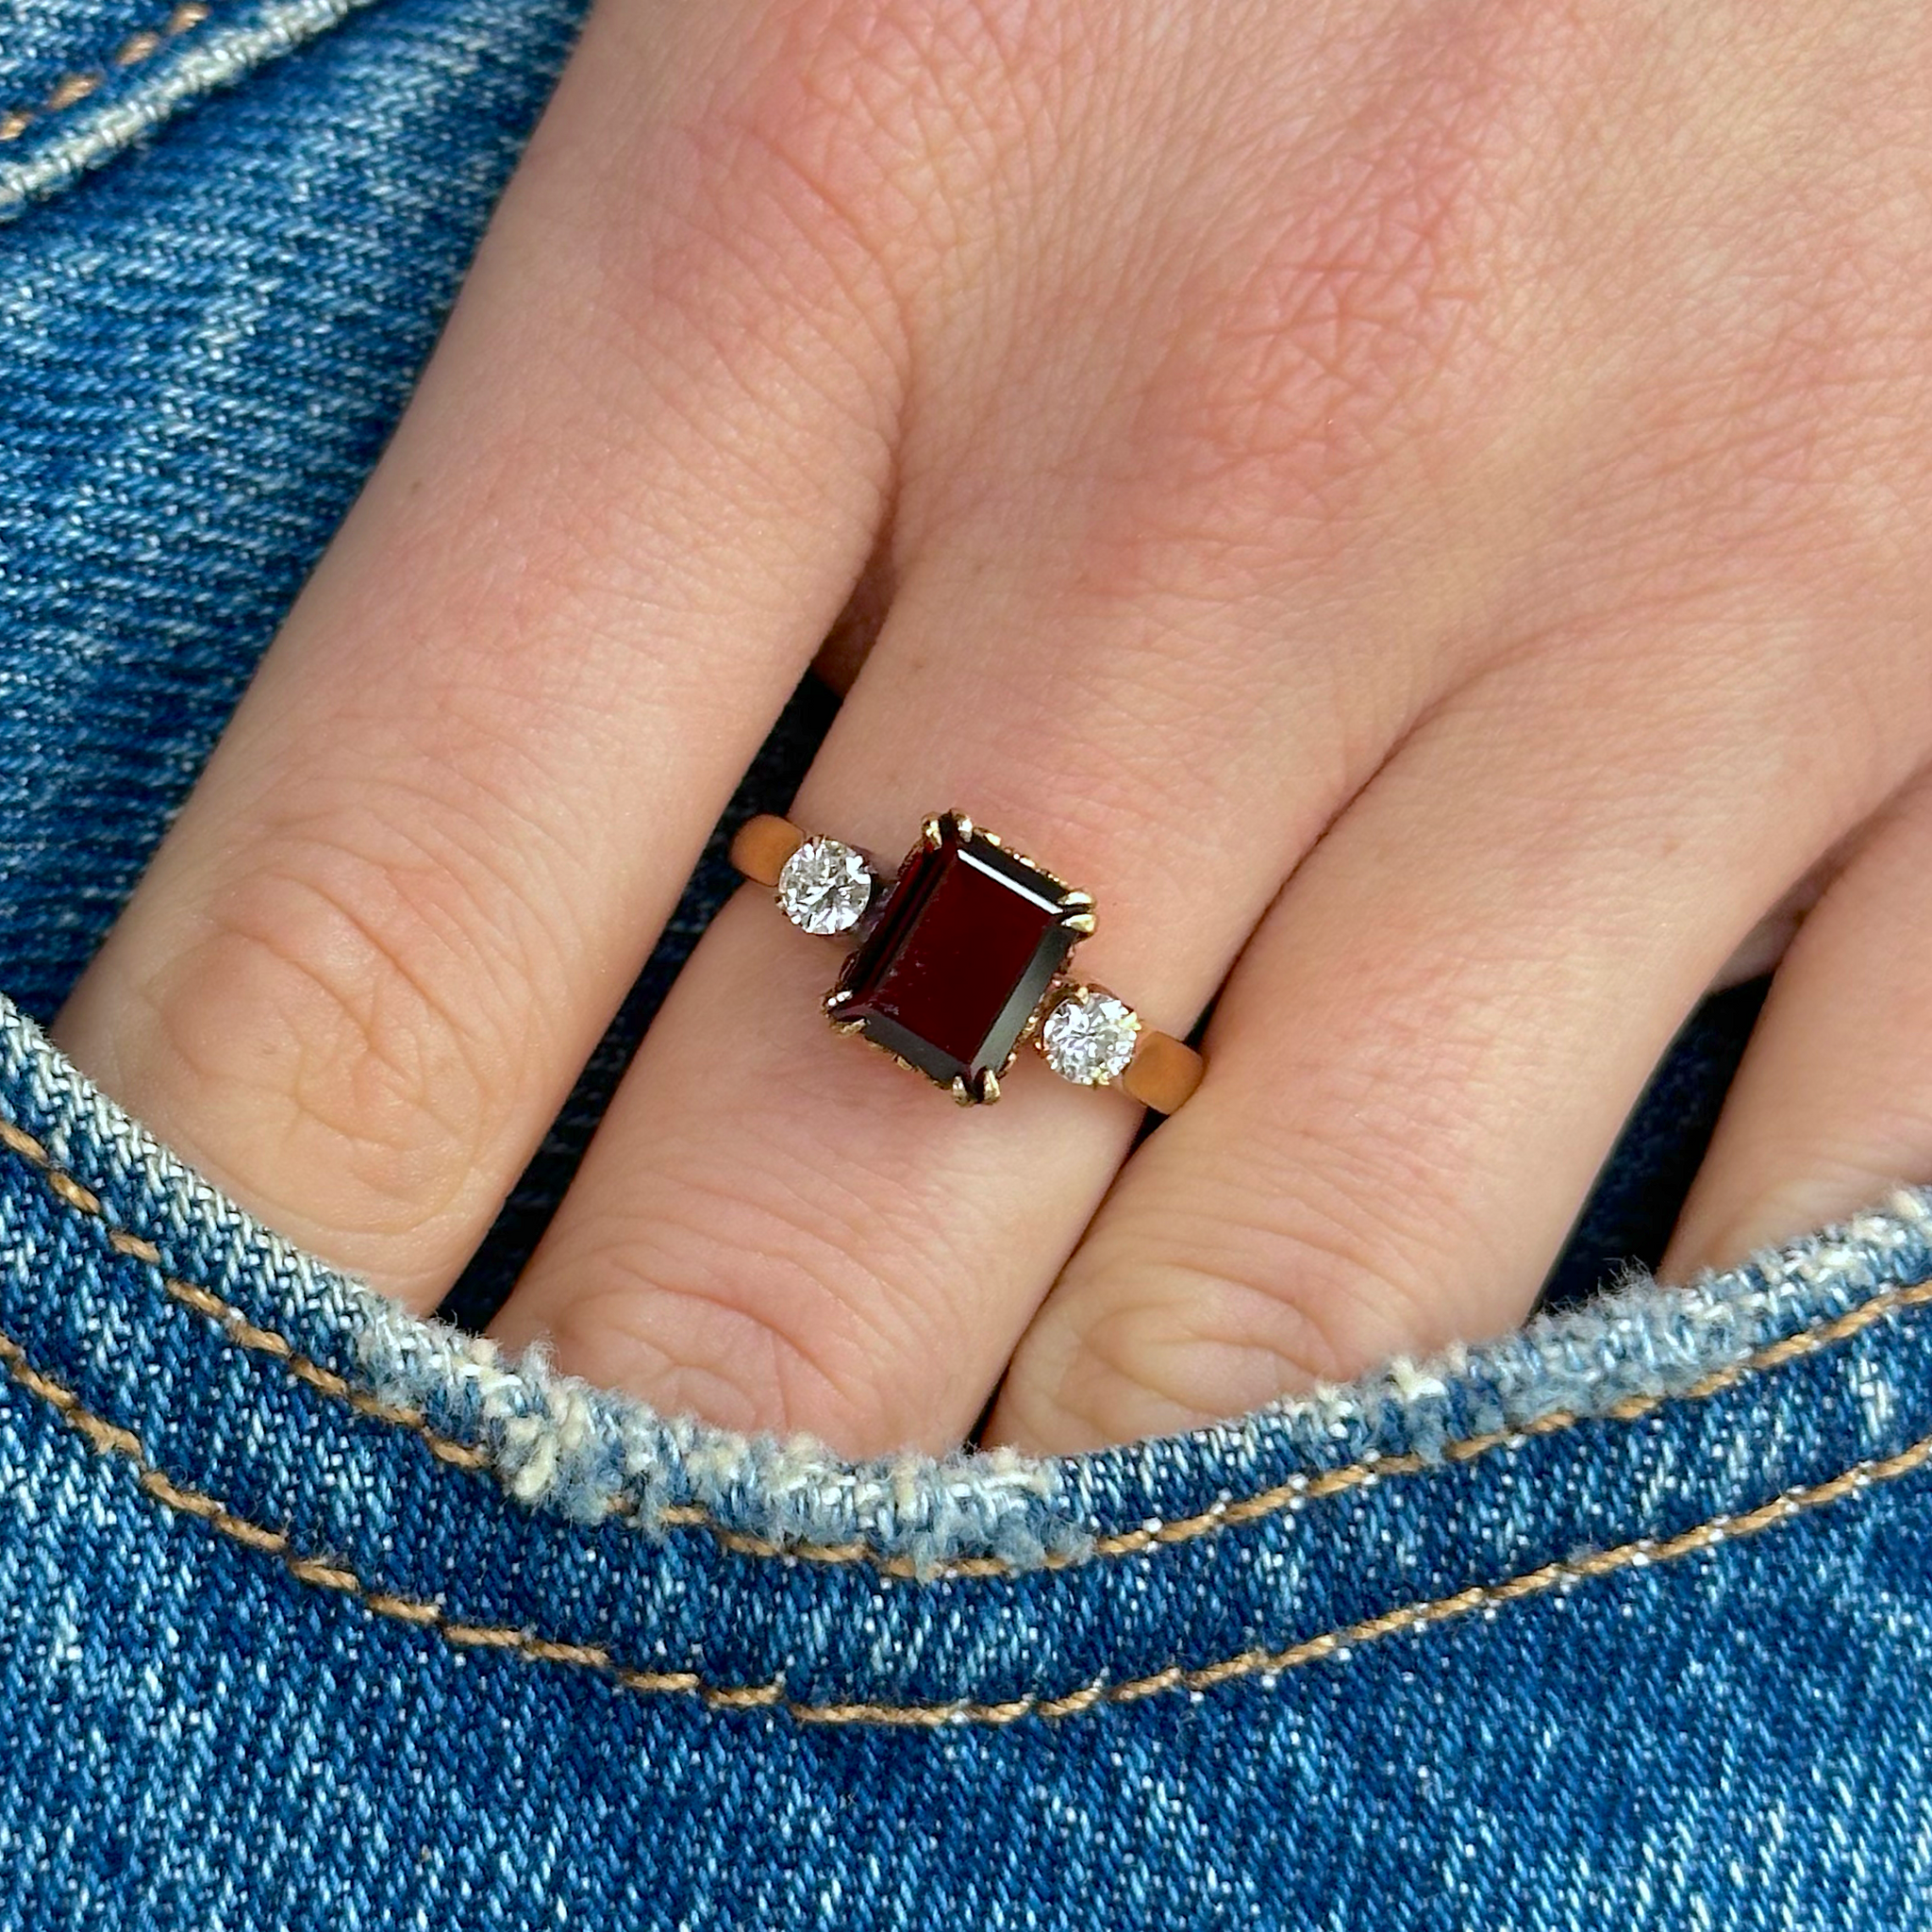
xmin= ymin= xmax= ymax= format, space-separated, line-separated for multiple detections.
xmin=0 ymin=1335 xmax=1932 ymax=1729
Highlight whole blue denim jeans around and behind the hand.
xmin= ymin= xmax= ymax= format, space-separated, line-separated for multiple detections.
xmin=0 ymin=0 xmax=1932 ymax=1932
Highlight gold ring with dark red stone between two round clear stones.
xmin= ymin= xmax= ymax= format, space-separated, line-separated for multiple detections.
xmin=730 ymin=811 xmax=1202 ymax=1113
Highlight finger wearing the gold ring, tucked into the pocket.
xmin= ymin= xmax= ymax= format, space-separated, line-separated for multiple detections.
xmin=480 ymin=537 xmax=1391 ymax=1453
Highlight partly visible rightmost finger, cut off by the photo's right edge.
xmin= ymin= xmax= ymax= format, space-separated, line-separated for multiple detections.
xmin=1659 ymin=778 xmax=1932 ymax=1281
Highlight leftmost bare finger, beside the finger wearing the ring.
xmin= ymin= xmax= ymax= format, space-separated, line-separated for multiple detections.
xmin=58 ymin=6 xmax=911 ymax=1306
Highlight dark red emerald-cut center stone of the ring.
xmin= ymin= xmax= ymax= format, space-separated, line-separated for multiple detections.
xmin=833 ymin=813 xmax=1080 ymax=1097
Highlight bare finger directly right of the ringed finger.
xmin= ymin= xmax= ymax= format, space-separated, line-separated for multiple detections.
xmin=990 ymin=638 xmax=1916 ymax=1451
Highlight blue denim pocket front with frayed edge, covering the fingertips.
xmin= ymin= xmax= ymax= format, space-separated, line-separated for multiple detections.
xmin=0 ymin=1010 xmax=1932 ymax=1932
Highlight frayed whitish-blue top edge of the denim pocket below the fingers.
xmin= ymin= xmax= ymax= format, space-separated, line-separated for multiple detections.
xmin=0 ymin=995 xmax=1932 ymax=1571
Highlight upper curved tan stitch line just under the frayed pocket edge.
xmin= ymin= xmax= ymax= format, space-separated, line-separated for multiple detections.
xmin=0 ymin=1117 xmax=1932 ymax=1582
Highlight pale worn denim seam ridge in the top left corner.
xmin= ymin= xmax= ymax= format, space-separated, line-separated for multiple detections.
xmin=0 ymin=0 xmax=388 ymax=223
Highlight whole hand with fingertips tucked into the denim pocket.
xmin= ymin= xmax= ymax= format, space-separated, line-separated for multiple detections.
xmin=45 ymin=0 xmax=1932 ymax=1453
